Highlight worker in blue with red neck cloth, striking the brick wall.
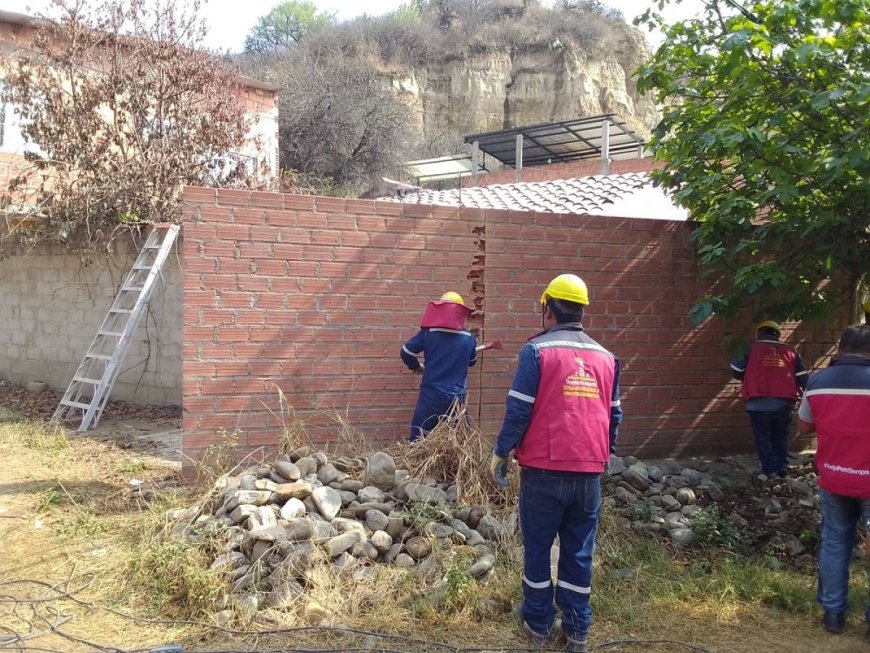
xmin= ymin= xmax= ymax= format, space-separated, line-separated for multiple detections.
xmin=401 ymin=292 xmax=477 ymax=441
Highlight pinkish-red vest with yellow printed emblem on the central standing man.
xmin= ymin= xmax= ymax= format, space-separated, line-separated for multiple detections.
xmin=516 ymin=331 xmax=616 ymax=474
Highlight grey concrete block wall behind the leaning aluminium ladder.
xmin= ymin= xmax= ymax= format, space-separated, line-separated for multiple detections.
xmin=0 ymin=232 xmax=182 ymax=405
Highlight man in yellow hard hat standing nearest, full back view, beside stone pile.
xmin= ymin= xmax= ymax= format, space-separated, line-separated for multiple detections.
xmin=490 ymin=274 xmax=622 ymax=653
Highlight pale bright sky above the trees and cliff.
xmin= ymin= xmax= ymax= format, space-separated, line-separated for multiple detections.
xmin=0 ymin=0 xmax=703 ymax=52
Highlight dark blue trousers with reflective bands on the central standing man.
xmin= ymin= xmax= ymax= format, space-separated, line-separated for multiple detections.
xmin=520 ymin=467 xmax=601 ymax=639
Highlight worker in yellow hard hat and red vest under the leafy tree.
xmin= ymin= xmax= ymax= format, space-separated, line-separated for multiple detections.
xmin=731 ymin=320 xmax=807 ymax=477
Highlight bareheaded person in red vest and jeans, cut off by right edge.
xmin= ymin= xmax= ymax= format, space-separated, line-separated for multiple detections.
xmin=798 ymin=324 xmax=870 ymax=642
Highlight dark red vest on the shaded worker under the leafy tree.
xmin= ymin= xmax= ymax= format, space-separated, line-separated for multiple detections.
xmin=741 ymin=340 xmax=800 ymax=401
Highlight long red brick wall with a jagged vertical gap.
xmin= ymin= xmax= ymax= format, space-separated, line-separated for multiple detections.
xmin=183 ymin=188 xmax=838 ymax=466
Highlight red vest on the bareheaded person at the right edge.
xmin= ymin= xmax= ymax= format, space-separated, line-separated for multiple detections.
xmin=807 ymin=388 xmax=870 ymax=498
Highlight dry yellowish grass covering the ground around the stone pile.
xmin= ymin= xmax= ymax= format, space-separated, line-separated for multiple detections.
xmin=0 ymin=420 xmax=866 ymax=653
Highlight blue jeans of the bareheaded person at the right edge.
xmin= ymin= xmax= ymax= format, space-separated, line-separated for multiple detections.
xmin=816 ymin=489 xmax=870 ymax=622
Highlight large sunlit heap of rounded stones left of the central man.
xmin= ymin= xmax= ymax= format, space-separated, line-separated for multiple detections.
xmin=166 ymin=447 xmax=517 ymax=619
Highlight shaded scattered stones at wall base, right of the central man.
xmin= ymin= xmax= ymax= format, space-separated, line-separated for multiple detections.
xmin=603 ymin=456 xmax=819 ymax=557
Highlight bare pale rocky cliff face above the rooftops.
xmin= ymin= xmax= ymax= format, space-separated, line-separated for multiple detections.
xmin=391 ymin=26 xmax=658 ymax=140
